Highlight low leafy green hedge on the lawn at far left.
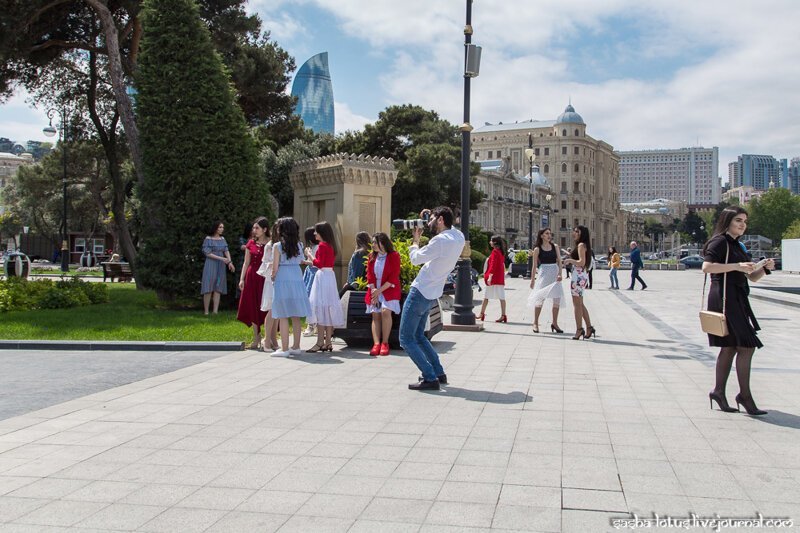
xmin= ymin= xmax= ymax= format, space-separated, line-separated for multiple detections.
xmin=0 ymin=277 xmax=108 ymax=313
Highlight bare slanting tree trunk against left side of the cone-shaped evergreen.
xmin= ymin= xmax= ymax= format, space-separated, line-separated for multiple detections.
xmin=86 ymin=0 xmax=144 ymax=188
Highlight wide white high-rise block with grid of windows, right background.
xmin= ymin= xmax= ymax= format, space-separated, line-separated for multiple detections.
xmin=617 ymin=146 xmax=721 ymax=205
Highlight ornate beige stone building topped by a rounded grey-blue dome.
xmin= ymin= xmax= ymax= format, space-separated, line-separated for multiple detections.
xmin=471 ymin=103 xmax=627 ymax=250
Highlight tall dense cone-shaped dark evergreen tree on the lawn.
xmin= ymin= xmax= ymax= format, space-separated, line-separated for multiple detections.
xmin=137 ymin=0 xmax=270 ymax=300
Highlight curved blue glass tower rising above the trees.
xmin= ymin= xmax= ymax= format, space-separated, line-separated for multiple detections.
xmin=292 ymin=52 xmax=335 ymax=135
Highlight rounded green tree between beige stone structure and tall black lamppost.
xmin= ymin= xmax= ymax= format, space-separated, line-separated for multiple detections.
xmin=337 ymin=104 xmax=483 ymax=218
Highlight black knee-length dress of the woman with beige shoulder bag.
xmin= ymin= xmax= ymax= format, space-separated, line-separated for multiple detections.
xmin=704 ymin=233 xmax=764 ymax=348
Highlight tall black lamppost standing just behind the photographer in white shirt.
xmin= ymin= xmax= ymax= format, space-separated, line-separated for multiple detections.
xmin=450 ymin=0 xmax=481 ymax=326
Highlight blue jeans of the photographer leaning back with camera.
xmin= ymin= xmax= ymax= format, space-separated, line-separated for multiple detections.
xmin=400 ymin=287 xmax=444 ymax=381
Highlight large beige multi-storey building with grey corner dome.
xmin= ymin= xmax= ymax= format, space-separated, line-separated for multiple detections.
xmin=471 ymin=105 xmax=626 ymax=250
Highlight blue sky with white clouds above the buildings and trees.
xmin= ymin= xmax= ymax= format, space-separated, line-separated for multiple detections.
xmin=0 ymin=0 xmax=800 ymax=182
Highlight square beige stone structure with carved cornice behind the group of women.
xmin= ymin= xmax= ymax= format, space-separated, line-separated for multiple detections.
xmin=289 ymin=154 xmax=398 ymax=287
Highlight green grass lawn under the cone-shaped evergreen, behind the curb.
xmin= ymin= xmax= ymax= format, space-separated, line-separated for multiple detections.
xmin=0 ymin=283 xmax=253 ymax=343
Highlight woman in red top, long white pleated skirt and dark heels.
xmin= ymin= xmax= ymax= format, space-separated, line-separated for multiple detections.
xmin=306 ymin=221 xmax=344 ymax=353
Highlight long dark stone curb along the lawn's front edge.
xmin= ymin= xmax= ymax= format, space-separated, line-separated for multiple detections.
xmin=0 ymin=340 xmax=244 ymax=352
